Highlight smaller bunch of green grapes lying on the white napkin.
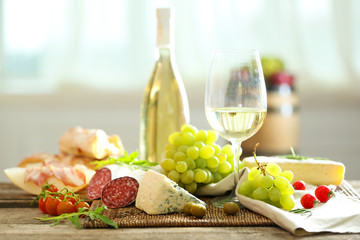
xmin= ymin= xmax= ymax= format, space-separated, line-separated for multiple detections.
xmin=238 ymin=162 xmax=295 ymax=210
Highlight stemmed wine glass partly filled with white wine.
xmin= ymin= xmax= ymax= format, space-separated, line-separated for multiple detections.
xmin=205 ymin=50 xmax=267 ymax=207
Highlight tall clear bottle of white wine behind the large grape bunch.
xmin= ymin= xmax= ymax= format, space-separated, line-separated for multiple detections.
xmin=139 ymin=8 xmax=189 ymax=162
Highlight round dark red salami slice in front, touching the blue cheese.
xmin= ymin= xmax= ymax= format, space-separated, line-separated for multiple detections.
xmin=101 ymin=177 xmax=139 ymax=208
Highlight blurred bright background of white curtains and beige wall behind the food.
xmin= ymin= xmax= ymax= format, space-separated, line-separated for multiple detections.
xmin=0 ymin=0 xmax=360 ymax=181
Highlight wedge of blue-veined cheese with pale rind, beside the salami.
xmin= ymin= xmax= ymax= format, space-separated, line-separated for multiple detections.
xmin=135 ymin=170 xmax=206 ymax=214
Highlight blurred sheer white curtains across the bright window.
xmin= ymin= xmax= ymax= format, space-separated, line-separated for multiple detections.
xmin=0 ymin=0 xmax=360 ymax=93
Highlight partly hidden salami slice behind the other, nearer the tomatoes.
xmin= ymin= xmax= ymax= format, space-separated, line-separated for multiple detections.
xmin=87 ymin=167 xmax=111 ymax=199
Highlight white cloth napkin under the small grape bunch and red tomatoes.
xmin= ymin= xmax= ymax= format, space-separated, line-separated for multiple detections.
xmin=236 ymin=168 xmax=360 ymax=235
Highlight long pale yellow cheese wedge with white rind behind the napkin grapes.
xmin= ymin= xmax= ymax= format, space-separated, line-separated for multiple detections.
xmin=243 ymin=156 xmax=345 ymax=185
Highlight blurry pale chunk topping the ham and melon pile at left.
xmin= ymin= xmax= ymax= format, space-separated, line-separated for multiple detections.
xmin=59 ymin=127 xmax=124 ymax=159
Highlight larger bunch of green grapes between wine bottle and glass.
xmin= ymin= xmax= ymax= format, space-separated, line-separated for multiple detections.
xmin=160 ymin=124 xmax=239 ymax=193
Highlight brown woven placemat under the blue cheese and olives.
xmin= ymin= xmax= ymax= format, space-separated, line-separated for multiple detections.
xmin=83 ymin=181 xmax=360 ymax=228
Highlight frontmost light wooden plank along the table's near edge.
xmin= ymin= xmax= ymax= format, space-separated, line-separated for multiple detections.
xmin=0 ymin=225 xmax=360 ymax=240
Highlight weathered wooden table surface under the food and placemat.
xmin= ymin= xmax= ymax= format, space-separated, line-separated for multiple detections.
xmin=0 ymin=181 xmax=360 ymax=240
